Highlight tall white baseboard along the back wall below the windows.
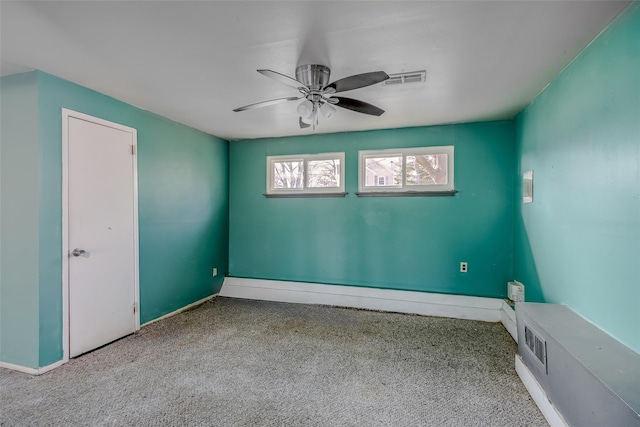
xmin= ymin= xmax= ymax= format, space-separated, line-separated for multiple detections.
xmin=220 ymin=277 xmax=503 ymax=322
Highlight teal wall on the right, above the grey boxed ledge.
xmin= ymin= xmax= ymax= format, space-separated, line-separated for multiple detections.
xmin=514 ymin=2 xmax=640 ymax=352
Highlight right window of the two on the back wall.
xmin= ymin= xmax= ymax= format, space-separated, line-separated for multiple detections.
xmin=358 ymin=145 xmax=454 ymax=193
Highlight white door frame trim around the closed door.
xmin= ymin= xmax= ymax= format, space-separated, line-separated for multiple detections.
xmin=62 ymin=108 xmax=140 ymax=362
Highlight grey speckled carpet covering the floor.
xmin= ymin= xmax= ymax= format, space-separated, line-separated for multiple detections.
xmin=0 ymin=298 xmax=547 ymax=427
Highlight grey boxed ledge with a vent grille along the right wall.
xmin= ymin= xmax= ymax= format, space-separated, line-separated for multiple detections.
xmin=516 ymin=303 xmax=640 ymax=427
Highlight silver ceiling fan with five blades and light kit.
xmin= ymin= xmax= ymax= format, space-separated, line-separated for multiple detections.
xmin=233 ymin=64 xmax=389 ymax=129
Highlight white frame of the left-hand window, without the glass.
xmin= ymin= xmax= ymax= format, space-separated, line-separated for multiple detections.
xmin=266 ymin=152 xmax=345 ymax=195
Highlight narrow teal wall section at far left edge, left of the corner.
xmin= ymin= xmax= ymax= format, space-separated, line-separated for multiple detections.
xmin=0 ymin=73 xmax=39 ymax=368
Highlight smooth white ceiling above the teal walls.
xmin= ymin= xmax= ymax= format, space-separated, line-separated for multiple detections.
xmin=0 ymin=0 xmax=629 ymax=140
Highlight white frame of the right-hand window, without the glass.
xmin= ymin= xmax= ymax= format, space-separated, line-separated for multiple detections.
xmin=358 ymin=145 xmax=455 ymax=193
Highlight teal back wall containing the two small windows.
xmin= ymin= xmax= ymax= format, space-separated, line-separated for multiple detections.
xmin=229 ymin=121 xmax=514 ymax=297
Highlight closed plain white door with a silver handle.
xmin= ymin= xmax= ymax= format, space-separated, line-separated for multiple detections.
xmin=67 ymin=116 xmax=138 ymax=357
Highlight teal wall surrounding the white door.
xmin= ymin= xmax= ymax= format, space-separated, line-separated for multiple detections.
xmin=2 ymin=72 xmax=228 ymax=366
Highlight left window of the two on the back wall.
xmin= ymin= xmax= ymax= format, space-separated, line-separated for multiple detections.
xmin=267 ymin=153 xmax=344 ymax=195
